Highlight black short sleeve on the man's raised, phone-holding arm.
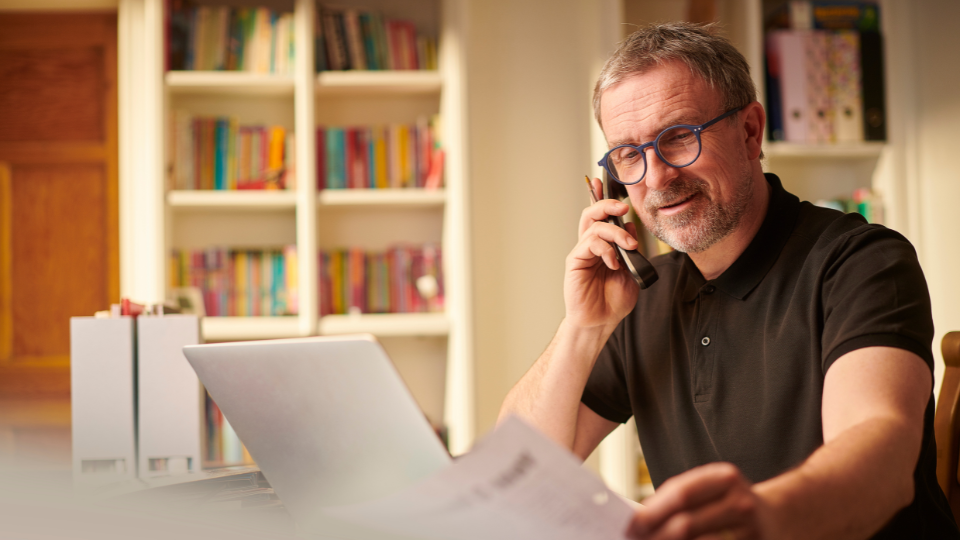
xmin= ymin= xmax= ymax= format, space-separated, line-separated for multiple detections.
xmin=580 ymin=317 xmax=633 ymax=424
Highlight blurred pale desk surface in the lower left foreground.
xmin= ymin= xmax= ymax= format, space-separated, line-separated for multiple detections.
xmin=0 ymin=467 xmax=302 ymax=540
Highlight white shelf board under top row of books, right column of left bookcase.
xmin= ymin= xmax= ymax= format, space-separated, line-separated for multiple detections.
xmin=316 ymin=70 xmax=443 ymax=96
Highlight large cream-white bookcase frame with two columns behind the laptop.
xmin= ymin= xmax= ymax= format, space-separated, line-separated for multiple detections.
xmin=140 ymin=0 xmax=474 ymax=460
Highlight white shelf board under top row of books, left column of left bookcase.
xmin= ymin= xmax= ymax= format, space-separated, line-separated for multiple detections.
xmin=166 ymin=71 xmax=294 ymax=96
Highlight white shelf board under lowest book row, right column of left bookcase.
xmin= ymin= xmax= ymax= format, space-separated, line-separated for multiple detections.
xmin=318 ymin=313 xmax=450 ymax=337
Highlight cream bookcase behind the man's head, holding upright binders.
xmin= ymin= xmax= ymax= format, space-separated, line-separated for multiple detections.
xmin=591 ymin=0 xmax=903 ymax=500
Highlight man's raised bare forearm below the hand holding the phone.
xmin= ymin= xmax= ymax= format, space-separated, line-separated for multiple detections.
xmin=499 ymin=320 xmax=613 ymax=449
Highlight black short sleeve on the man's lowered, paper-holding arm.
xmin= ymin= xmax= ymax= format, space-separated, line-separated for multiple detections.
xmin=821 ymin=218 xmax=933 ymax=373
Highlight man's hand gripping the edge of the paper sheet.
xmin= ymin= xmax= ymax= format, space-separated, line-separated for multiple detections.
xmin=627 ymin=463 xmax=767 ymax=540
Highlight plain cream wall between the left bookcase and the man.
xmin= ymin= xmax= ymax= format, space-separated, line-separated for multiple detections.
xmin=467 ymin=0 xmax=615 ymax=434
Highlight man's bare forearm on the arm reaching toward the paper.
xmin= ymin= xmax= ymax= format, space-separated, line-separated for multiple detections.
xmin=754 ymin=418 xmax=920 ymax=540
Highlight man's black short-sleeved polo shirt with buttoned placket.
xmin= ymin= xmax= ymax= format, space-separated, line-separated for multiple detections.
xmin=582 ymin=174 xmax=960 ymax=538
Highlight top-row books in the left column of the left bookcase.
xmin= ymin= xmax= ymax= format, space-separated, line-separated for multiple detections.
xmin=167 ymin=0 xmax=294 ymax=75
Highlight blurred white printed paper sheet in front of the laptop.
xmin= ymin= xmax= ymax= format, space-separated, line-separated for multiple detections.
xmin=323 ymin=418 xmax=634 ymax=540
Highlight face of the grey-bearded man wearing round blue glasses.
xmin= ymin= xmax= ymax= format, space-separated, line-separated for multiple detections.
xmin=600 ymin=62 xmax=753 ymax=253
